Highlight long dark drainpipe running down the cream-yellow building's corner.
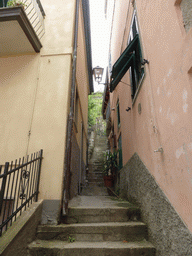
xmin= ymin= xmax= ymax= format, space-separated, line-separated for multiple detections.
xmin=61 ymin=0 xmax=80 ymax=215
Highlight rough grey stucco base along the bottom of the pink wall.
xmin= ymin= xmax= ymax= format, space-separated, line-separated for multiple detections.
xmin=120 ymin=153 xmax=192 ymax=256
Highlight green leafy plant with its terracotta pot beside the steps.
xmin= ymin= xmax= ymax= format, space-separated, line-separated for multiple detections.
xmin=103 ymin=150 xmax=118 ymax=187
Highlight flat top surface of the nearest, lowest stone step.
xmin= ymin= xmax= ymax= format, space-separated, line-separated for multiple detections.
xmin=28 ymin=240 xmax=155 ymax=249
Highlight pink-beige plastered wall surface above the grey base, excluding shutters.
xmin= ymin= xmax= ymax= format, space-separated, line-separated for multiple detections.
xmin=111 ymin=0 xmax=192 ymax=231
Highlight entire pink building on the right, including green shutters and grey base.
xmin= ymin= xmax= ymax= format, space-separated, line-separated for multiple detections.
xmin=103 ymin=0 xmax=192 ymax=255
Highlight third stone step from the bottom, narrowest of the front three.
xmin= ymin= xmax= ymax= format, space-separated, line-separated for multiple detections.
xmin=66 ymin=205 xmax=140 ymax=223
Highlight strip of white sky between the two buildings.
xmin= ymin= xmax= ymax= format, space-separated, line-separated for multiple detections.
xmin=89 ymin=0 xmax=109 ymax=92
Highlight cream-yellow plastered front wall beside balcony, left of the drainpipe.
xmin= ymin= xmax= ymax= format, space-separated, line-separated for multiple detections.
xmin=0 ymin=0 xmax=75 ymax=199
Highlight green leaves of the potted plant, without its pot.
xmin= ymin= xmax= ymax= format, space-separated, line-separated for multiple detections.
xmin=103 ymin=151 xmax=118 ymax=176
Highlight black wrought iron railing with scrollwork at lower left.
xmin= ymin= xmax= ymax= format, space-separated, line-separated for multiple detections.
xmin=0 ymin=150 xmax=43 ymax=236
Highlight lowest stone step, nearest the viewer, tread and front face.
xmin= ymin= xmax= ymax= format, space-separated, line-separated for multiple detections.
xmin=28 ymin=240 xmax=155 ymax=256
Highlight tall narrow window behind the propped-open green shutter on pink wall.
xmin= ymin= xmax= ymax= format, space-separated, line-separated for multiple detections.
xmin=128 ymin=11 xmax=144 ymax=99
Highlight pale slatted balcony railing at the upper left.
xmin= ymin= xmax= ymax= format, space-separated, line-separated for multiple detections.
xmin=0 ymin=0 xmax=45 ymax=39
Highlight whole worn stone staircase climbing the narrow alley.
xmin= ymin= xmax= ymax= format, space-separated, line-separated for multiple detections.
xmin=29 ymin=135 xmax=155 ymax=256
